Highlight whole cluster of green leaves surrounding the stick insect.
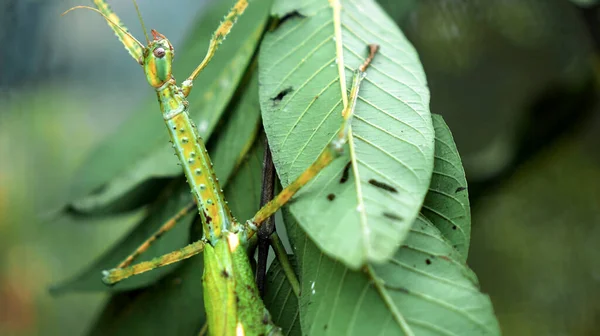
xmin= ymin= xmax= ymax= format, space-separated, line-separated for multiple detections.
xmin=57 ymin=0 xmax=500 ymax=335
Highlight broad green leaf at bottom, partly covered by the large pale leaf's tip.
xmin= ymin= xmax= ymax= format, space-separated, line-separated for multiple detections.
xmin=284 ymin=211 xmax=500 ymax=335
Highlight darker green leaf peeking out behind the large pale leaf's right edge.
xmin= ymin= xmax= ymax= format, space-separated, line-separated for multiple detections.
xmin=421 ymin=114 xmax=471 ymax=262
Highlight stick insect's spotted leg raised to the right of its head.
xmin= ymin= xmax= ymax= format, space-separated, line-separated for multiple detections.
xmin=181 ymin=0 xmax=248 ymax=97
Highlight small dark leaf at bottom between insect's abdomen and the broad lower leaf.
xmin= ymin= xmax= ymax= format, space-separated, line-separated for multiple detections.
xmin=263 ymin=255 xmax=302 ymax=335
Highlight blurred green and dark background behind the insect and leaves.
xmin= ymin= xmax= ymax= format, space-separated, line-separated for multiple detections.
xmin=0 ymin=0 xmax=600 ymax=335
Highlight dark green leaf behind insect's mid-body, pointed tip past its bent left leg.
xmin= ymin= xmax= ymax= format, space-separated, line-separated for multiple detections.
xmin=55 ymin=72 xmax=260 ymax=292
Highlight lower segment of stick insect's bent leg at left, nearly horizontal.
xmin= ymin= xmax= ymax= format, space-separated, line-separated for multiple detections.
xmin=102 ymin=240 xmax=206 ymax=285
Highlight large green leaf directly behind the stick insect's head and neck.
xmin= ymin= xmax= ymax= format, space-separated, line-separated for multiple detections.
xmin=72 ymin=0 xmax=271 ymax=212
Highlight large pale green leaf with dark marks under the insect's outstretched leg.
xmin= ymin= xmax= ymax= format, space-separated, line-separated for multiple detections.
xmin=259 ymin=0 xmax=434 ymax=269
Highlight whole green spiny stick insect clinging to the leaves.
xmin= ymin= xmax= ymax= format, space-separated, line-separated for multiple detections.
xmin=63 ymin=0 xmax=378 ymax=335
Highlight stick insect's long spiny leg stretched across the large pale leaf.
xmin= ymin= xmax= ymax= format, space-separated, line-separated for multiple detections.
xmin=245 ymin=44 xmax=379 ymax=237
